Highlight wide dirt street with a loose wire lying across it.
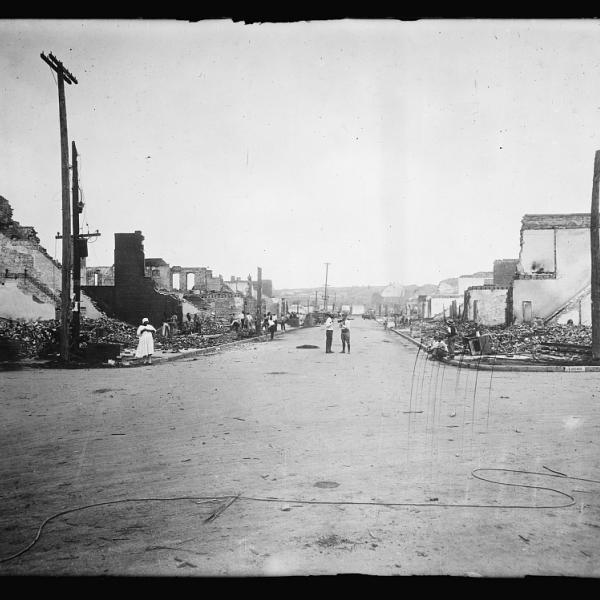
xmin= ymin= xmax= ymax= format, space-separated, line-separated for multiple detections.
xmin=0 ymin=318 xmax=600 ymax=577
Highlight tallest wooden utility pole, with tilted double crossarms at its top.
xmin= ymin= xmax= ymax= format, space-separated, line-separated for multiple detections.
xmin=40 ymin=52 xmax=77 ymax=361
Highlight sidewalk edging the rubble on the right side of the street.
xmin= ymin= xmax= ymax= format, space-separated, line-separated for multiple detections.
xmin=390 ymin=328 xmax=600 ymax=373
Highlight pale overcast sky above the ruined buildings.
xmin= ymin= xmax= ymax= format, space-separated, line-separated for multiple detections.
xmin=0 ymin=20 xmax=600 ymax=288
